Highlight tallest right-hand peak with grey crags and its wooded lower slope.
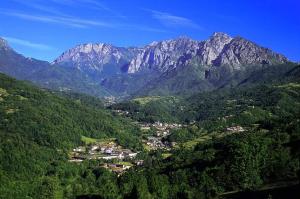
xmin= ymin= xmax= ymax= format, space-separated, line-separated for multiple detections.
xmin=136 ymin=33 xmax=295 ymax=95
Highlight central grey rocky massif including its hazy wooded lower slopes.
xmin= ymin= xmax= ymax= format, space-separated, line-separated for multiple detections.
xmin=49 ymin=32 xmax=288 ymax=95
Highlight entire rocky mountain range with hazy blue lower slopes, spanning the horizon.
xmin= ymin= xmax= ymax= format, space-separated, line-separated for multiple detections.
xmin=0 ymin=32 xmax=295 ymax=97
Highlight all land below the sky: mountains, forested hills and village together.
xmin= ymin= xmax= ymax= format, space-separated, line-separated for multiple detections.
xmin=0 ymin=19 xmax=300 ymax=199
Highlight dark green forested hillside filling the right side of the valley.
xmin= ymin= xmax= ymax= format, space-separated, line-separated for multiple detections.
xmin=109 ymin=74 xmax=300 ymax=198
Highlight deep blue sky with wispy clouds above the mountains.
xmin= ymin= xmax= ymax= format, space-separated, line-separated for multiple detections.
xmin=0 ymin=0 xmax=300 ymax=61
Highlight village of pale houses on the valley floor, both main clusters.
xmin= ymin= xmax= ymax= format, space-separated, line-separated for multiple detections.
xmin=69 ymin=121 xmax=183 ymax=176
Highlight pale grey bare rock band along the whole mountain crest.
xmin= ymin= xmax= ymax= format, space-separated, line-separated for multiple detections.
xmin=53 ymin=32 xmax=288 ymax=74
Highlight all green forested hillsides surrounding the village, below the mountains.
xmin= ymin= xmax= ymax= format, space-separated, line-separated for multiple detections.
xmin=0 ymin=69 xmax=300 ymax=199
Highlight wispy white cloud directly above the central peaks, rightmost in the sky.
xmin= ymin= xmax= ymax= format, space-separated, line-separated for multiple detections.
xmin=147 ymin=10 xmax=203 ymax=29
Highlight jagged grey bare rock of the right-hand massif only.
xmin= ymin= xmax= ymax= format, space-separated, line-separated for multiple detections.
xmin=128 ymin=32 xmax=288 ymax=73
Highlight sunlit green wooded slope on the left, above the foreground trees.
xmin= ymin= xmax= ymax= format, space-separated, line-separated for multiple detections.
xmin=0 ymin=74 xmax=142 ymax=148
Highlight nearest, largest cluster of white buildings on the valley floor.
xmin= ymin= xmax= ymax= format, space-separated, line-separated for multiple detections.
xmin=70 ymin=142 xmax=137 ymax=162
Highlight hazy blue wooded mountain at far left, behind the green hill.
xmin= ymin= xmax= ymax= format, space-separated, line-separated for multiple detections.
xmin=0 ymin=38 xmax=110 ymax=96
